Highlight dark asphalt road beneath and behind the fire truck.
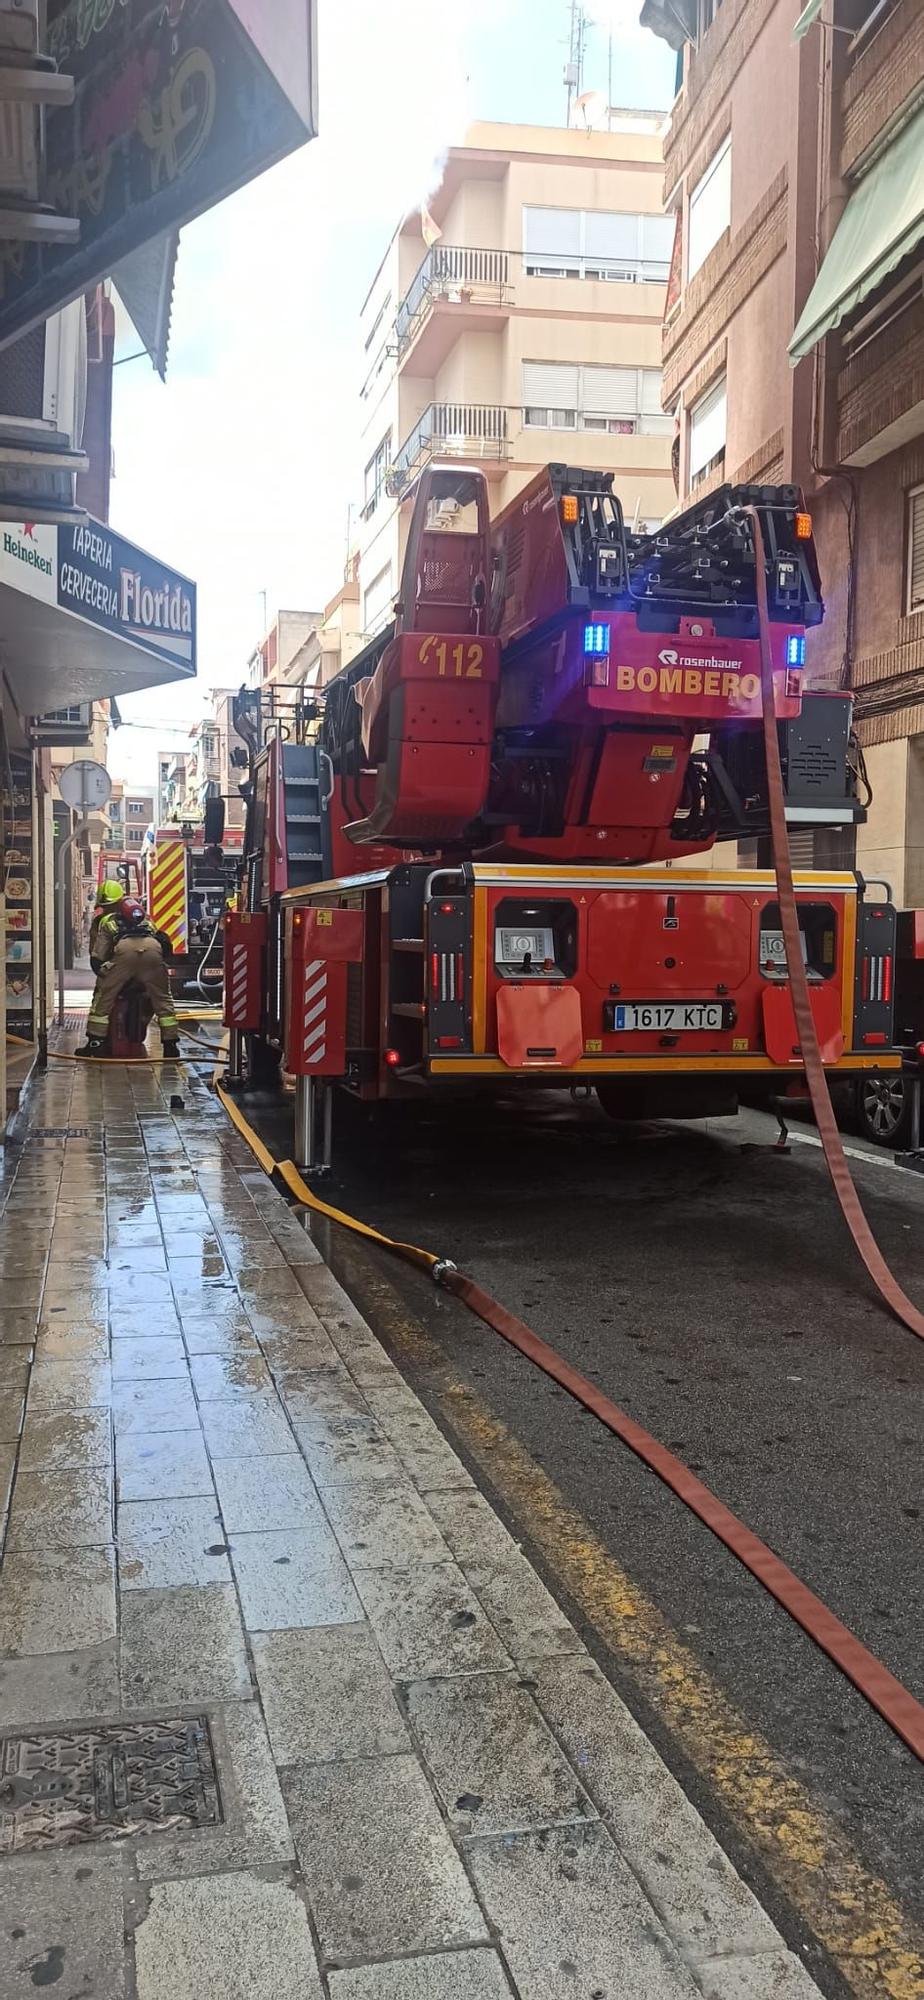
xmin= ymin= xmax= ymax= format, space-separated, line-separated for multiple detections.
xmin=235 ymin=1094 xmax=924 ymax=2000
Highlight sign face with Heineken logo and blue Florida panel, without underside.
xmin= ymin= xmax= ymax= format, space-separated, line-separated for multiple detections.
xmin=0 ymin=520 xmax=196 ymax=678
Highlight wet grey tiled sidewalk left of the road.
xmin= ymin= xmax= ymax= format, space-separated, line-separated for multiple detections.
xmin=0 ymin=1064 xmax=818 ymax=2000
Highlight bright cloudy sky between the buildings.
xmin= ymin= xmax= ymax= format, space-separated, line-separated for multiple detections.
xmin=110 ymin=0 xmax=674 ymax=784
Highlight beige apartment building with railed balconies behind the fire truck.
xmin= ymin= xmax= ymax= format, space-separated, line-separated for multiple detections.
xmin=358 ymin=112 xmax=674 ymax=638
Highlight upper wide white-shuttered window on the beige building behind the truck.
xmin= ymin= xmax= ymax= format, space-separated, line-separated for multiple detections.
xmin=522 ymin=208 xmax=674 ymax=284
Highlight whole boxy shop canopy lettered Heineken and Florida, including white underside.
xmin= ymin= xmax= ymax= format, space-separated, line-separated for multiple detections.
xmin=0 ymin=520 xmax=196 ymax=716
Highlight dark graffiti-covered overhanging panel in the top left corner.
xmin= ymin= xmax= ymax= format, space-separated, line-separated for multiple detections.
xmin=0 ymin=0 xmax=316 ymax=346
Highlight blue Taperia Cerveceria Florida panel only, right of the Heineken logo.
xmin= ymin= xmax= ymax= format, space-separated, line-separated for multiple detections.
xmin=58 ymin=524 xmax=196 ymax=664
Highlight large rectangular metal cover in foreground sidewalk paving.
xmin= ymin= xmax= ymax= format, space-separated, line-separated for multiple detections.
xmin=0 ymin=1716 xmax=222 ymax=1854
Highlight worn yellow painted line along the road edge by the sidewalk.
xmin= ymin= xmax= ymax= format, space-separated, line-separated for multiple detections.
xmin=346 ymin=1246 xmax=924 ymax=2000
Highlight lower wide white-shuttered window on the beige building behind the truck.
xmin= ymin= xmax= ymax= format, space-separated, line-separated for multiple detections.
xmin=522 ymin=362 xmax=674 ymax=438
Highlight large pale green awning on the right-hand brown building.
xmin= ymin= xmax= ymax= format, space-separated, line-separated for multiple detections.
xmin=790 ymin=110 xmax=924 ymax=364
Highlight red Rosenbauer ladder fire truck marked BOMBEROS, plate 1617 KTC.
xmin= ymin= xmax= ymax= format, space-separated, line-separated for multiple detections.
xmin=226 ymin=466 xmax=902 ymax=1166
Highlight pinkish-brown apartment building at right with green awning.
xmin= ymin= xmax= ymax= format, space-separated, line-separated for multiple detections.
xmin=642 ymin=0 xmax=924 ymax=904
